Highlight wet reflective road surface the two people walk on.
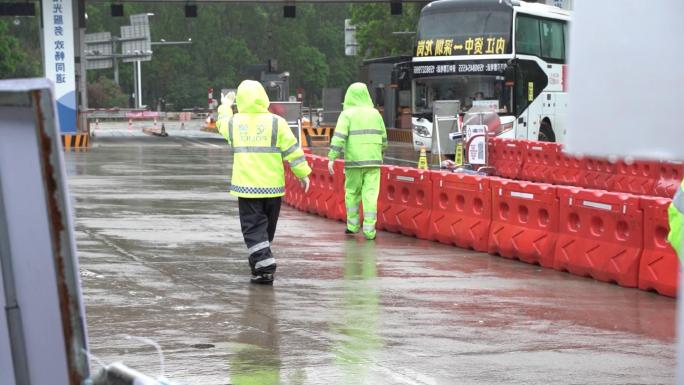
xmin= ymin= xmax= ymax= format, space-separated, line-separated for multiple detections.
xmin=66 ymin=137 xmax=675 ymax=385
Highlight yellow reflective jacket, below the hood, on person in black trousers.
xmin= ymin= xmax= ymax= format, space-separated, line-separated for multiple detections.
xmin=227 ymin=113 xmax=311 ymax=198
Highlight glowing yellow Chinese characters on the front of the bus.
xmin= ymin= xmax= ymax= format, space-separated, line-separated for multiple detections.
xmin=416 ymin=36 xmax=507 ymax=57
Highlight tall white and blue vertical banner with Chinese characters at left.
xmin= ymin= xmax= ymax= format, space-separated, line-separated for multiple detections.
xmin=42 ymin=0 xmax=76 ymax=133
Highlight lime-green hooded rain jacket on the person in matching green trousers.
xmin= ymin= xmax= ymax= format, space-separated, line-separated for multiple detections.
xmin=328 ymin=83 xmax=387 ymax=168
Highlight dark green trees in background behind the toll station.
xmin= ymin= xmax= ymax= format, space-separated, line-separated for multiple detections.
xmin=0 ymin=3 xmax=423 ymax=110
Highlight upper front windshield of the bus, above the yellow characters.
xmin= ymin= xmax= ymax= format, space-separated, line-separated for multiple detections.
xmin=417 ymin=10 xmax=513 ymax=47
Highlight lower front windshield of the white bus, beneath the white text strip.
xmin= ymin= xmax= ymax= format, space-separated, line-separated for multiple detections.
xmin=413 ymin=75 xmax=511 ymax=115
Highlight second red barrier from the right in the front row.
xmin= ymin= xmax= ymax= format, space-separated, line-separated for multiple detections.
xmin=554 ymin=186 xmax=644 ymax=287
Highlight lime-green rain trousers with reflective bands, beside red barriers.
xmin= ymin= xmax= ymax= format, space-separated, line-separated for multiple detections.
xmin=344 ymin=167 xmax=380 ymax=239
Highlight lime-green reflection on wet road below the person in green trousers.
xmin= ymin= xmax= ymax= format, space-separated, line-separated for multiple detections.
xmin=334 ymin=239 xmax=382 ymax=385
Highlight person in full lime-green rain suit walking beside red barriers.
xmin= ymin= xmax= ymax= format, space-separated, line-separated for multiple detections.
xmin=328 ymin=83 xmax=387 ymax=239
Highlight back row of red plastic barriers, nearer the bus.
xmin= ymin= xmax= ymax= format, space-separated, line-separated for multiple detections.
xmin=488 ymin=138 xmax=684 ymax=197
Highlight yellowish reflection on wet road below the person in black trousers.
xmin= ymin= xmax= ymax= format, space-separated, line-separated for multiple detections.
xmin=229 ymin=286 xmax=281 ymax=385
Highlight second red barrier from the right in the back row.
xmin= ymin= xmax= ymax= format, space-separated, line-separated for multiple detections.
xmin=613 ymin=161 xmax=658 ymax=195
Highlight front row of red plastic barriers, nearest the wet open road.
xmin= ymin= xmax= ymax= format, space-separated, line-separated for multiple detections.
xmin=285 ymin=154 xmax=679 ymax=297
